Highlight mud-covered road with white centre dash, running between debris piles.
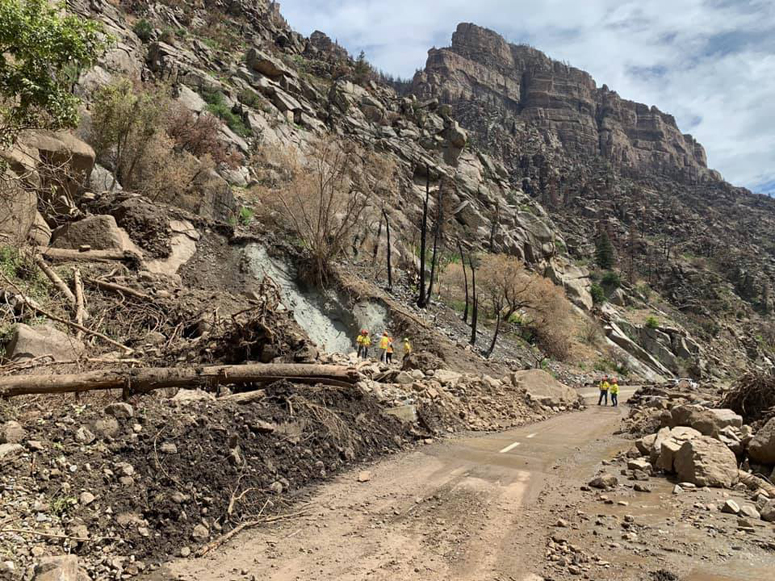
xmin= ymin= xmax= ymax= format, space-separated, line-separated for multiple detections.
xmin=156 ymin=389 xmax=634 ymax=581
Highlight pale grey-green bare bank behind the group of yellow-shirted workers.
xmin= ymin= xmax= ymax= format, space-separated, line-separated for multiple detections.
xmin=245 ymin=244 xmax=388 ymax=353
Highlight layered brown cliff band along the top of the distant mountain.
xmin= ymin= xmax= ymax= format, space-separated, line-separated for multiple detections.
xmin=413 ymin=24 xmax=720 ymax=183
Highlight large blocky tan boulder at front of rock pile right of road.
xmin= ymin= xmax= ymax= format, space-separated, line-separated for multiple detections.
xmin=674 ymin=436 xmax=738 ymax=488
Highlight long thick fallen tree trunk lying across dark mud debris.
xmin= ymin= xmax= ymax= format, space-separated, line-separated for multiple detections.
xmin=0 ymin=363 xmax=360 ymax=399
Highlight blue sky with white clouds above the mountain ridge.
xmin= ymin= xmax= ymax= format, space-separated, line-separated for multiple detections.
xmin=280 ymin=0 xmax=775 ymax=194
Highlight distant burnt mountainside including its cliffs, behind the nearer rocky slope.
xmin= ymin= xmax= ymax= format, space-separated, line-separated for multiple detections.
xmin=411 ymin=24 xmax=775 ymax=376
